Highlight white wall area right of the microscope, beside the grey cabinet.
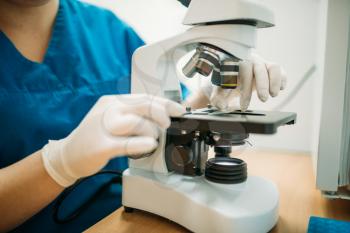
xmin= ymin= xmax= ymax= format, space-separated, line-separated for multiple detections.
xmin=247 ymin=0 xmax=319 ymax=151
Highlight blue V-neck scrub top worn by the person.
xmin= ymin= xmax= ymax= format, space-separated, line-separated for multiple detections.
xmin=0 ymin=0 xmax=189 ymax=233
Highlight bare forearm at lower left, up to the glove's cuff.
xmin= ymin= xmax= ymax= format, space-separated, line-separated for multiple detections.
xmin=0 ymin=151 xmax=64 ymax=232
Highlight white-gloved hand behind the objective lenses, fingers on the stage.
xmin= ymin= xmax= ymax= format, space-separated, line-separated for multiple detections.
xmin=202 ymin=54 xmax=287 ymax=111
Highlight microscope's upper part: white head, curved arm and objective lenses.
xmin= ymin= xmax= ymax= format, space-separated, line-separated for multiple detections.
xmin=131 ymin=0 xmax=274 ymax=98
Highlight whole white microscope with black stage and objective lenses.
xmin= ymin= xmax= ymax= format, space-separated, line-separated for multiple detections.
xmin=122 ymin=0 xmax=296 ymax=233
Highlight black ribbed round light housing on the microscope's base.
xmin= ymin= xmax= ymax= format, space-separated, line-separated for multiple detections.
xmin=205 ymin=157 xmax=248 ymax=184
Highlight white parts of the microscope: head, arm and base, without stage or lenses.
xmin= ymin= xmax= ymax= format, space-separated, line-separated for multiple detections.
xmin=122 ymin=0 xmax=279 ymax=233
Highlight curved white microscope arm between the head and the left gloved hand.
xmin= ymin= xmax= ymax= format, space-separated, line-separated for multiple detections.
xmin=131 ymin=24 xmax=256 ymax=102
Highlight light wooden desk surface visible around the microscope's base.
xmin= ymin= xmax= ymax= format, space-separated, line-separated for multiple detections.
xmin=87 ymin=151 xmax=350 ymax=233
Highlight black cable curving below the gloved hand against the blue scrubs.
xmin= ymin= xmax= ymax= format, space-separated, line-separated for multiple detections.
xmin=52 ymin=170 xmax=123 ymax=224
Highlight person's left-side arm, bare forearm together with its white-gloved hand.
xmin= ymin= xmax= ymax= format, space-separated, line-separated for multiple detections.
xmin=0 ymin=95 xmax=185 ymax=232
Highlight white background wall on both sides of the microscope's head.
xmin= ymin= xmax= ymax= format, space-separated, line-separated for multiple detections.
xmin=86 ymin=0 xmax=319 ymax=151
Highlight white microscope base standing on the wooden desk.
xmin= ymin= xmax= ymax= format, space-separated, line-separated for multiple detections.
xmin=123 ymin=169 xmax=279 ymax=233
